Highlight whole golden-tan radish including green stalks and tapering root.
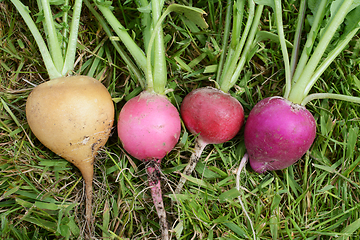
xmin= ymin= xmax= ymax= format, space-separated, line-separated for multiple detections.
xmin=11 ymin=0 xmax=114 ymax=234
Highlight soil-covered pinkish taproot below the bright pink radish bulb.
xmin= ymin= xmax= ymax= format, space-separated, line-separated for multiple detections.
xmin=146 ymin=159 xmax=169 ymax=240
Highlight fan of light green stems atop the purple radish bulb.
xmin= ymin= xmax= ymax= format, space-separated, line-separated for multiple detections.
xmin=274 ymin=0 xmax=360 ymax=105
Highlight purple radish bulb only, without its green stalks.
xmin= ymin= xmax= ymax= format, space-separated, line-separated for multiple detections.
xmin=244 ymin=97 xmax=316 ymax=173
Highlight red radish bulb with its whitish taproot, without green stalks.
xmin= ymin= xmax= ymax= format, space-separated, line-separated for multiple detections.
xmin=175 ymin=87 xmax=244 ymax=193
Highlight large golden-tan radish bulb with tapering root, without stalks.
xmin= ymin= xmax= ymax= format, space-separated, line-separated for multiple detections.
xmin=26 ymin=76 xmax=114 ymax=232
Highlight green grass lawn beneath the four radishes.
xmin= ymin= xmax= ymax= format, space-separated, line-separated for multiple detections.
xmin=0 ymin=1 xmax=360 ymax=240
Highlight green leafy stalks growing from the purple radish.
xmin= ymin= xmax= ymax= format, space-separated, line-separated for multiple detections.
xmin=256 ymin=0 xmax=360 ymax=105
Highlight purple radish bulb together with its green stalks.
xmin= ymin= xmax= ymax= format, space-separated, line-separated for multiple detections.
xmin=244 ymin=0 xmax=360 ymax=173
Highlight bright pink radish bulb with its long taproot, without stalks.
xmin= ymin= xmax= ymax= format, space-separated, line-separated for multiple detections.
xmin=118 ymin=91 xmax=181 ymax=239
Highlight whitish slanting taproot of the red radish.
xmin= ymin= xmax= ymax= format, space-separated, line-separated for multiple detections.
xmin=175 ymin=138 xmax=207 ymax=194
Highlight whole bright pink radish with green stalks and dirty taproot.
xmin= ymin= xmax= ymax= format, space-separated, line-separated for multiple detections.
xmin=89 ymin=0 xmax=207 ymax=240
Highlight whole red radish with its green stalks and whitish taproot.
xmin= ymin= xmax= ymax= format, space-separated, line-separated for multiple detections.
xmin=175 ymin=0 xmax=263 ymax=193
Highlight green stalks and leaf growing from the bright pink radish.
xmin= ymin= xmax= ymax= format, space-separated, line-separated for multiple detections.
xmin=92 ymin=0 xmax=208 ymax=94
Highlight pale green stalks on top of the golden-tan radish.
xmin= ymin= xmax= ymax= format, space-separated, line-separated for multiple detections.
xmin=11 ymin=0 xmax=82 ymax=79
